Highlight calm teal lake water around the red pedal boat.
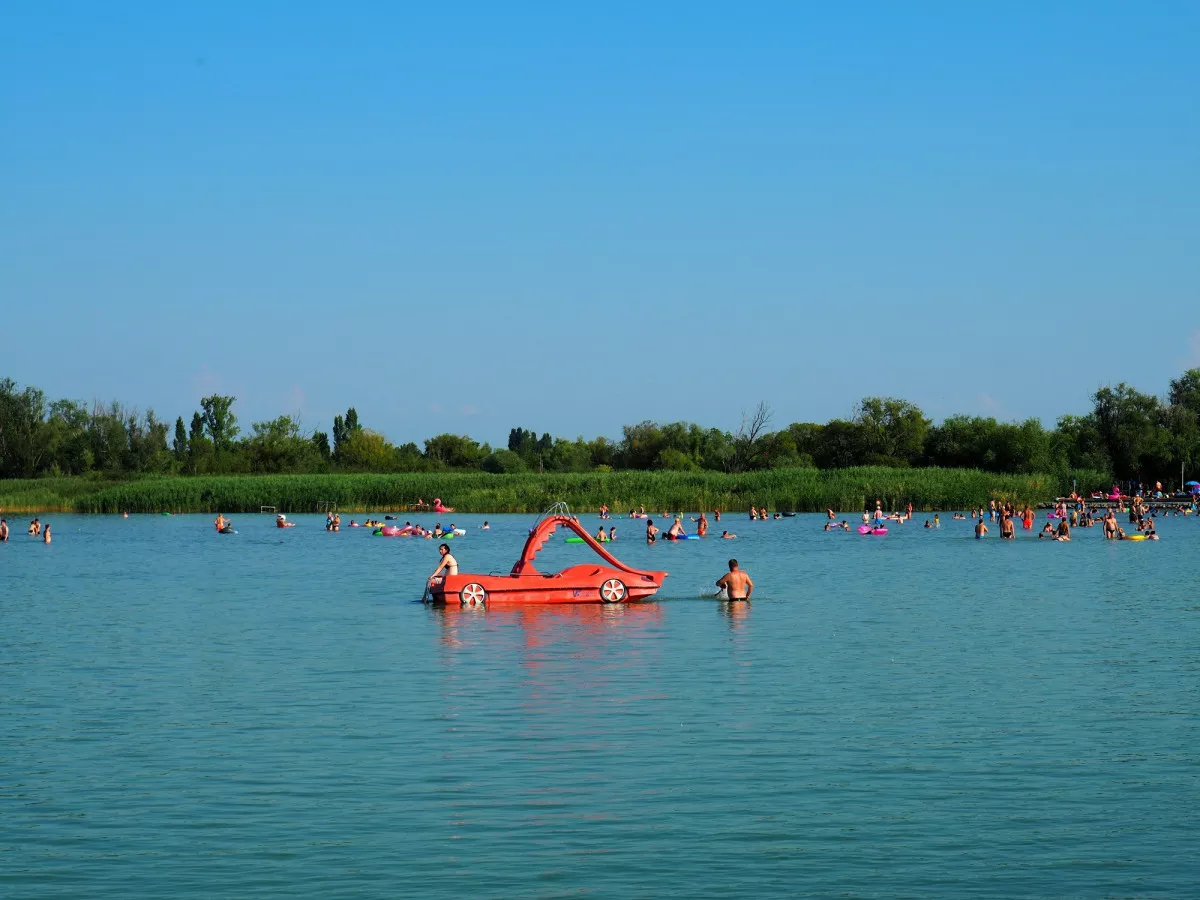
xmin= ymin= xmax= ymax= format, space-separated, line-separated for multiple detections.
xmin=0 ymin=515 xmax=1200 ymax=898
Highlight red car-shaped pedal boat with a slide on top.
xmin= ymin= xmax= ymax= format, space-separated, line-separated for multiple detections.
xmin=430 ymin=506 xmax=667 ymax=606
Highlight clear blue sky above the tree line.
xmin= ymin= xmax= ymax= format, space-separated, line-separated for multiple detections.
xmin=0 ymin=1 xmax=1200 ymax=443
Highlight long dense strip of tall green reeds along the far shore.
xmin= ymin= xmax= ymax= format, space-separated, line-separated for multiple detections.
xmin=46 ymin=467 xmax=1108 ymax=514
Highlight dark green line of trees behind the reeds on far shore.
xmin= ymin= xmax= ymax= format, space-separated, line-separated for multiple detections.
xmin=0 ymin=368 xmax=1200 ymax=484
